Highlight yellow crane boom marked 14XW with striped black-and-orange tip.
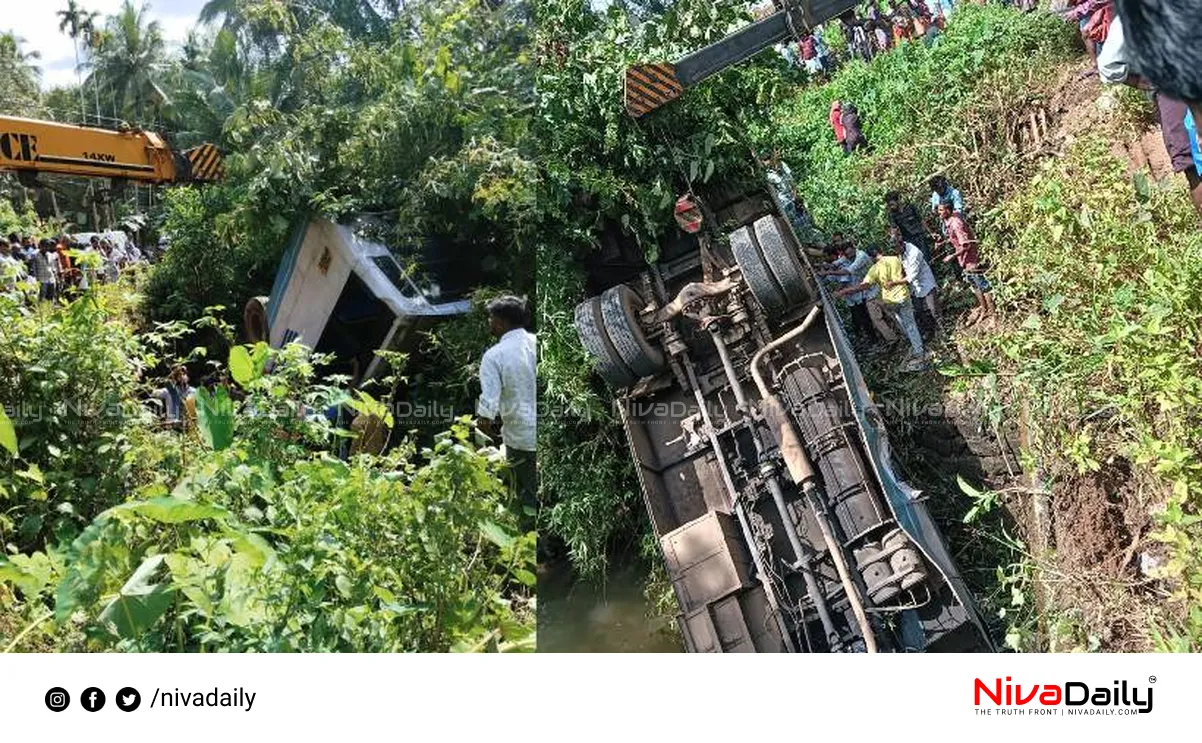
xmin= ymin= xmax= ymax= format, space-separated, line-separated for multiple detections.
xmin=0 ymin=115 xmax=224 ymax=183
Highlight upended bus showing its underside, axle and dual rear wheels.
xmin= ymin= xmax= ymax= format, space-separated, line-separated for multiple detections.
xmin=575 ymin=182 xmax=992 ymax=652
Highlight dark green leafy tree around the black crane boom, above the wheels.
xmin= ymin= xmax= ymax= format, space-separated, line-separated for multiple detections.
xmin=535 ymin=0 xmax=785 ymax=260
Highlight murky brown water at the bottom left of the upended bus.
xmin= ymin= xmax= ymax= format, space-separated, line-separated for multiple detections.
xmin=538 ymin=563 xmax=682 ymax=653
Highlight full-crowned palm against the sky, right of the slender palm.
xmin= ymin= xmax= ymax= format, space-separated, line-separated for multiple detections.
xmin=89 ymin=0 xmax=169 ymax=121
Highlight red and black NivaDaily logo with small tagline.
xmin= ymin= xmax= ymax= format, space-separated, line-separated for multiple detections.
xmin=972 ymin=676 xmax=1156 ymax=715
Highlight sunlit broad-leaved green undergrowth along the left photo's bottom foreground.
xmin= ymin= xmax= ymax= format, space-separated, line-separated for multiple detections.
xmin=7 ymin=413 xmax=534 ymax=652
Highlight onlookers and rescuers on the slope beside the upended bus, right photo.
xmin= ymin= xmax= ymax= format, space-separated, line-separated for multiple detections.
xmin=761 ymin=0 xmax=1202 ymax=369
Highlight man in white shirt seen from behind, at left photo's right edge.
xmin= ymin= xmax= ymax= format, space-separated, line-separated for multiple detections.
xmin=476 ymin=297 xmax=538 ymax=529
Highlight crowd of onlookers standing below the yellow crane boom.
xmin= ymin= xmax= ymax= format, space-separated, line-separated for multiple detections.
xmin=0 ymin=232 xmax=147 ymax=302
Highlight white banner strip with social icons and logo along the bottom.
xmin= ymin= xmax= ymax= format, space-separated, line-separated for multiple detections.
xmin=0 ymin=654 xmax=1182 ymax=743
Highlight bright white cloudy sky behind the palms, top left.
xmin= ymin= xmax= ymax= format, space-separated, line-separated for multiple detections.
xmin=0 ymin=0 xmax=206 ymax=90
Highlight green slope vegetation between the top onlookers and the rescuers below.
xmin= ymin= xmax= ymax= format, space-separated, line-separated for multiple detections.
xmin=752 ymin=4 xmax=1076 ymax=240
